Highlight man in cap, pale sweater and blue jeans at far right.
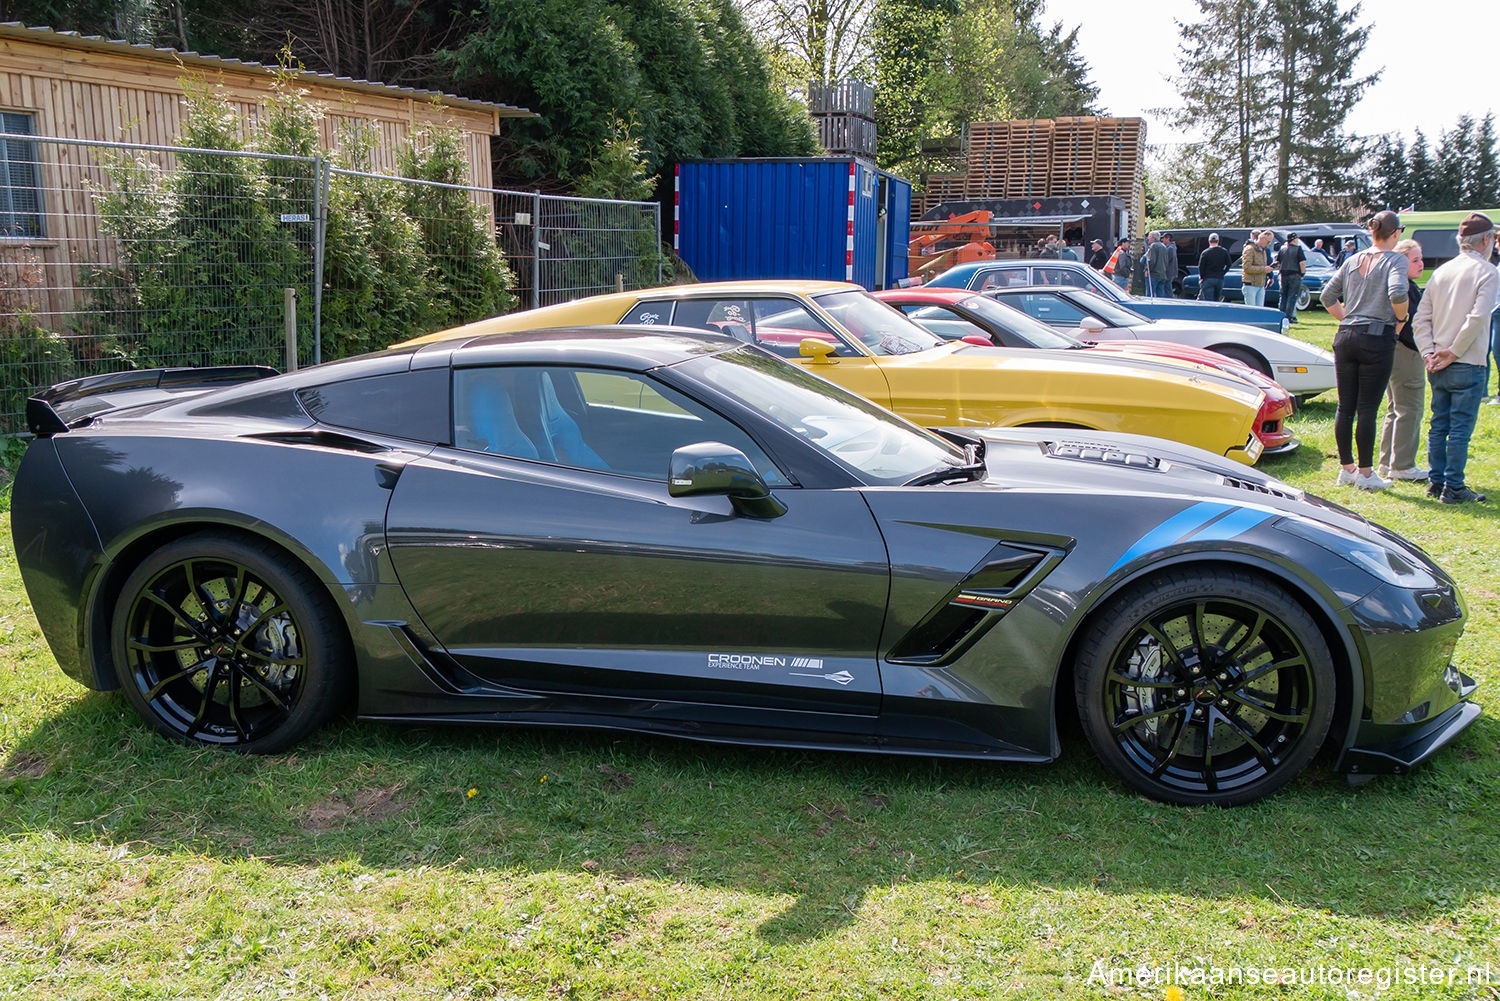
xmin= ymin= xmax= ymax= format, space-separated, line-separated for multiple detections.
xmin=1412 ymin=212 xmax=1500 ymax=504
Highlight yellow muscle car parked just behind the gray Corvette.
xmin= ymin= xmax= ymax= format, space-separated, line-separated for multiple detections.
xmin=407 ymin=281 xmax=1263 ymax=465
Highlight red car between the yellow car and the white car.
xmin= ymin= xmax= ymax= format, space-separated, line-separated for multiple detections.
xmin=875 ymin=288 xmax=1302 ymax=455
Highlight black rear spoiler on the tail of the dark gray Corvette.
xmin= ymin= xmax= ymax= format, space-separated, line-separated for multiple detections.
xmin=26 ymin=365 xmax=281 ymax=438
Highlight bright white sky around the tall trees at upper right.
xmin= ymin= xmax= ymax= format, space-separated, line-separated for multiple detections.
xmin=1043 ymin=0 xmax=1500 ymax=144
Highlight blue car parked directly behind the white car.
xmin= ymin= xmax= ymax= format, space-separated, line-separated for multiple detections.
xmin=927 ymin=260 xmax=1286 ymax=333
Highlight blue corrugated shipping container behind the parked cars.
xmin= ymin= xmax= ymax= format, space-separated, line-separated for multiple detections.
xmin=674 ymin=156 xmax=912 ymax=288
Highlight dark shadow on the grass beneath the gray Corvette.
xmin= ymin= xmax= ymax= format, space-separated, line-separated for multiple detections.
xmin=0 ymin=693 xmax=1500 ymax=942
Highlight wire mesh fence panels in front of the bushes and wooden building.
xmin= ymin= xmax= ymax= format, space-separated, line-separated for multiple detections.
xmin=0 ymin=135 xmax=662 ymax=432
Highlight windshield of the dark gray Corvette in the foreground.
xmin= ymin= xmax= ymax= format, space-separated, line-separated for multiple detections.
xmin=680 ymin=348 xmax=966 ymax=485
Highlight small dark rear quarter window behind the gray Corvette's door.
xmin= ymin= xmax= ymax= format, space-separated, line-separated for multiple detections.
xmin=297 ymin=369 xmax=452 ymax=444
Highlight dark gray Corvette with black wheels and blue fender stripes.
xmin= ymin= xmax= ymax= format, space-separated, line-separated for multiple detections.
xmin=12 ymin=327 xmax=1479 ymax=806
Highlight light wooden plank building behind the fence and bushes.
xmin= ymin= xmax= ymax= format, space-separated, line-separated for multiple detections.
xmin=0 ymin=24 xmax=536 ymax=330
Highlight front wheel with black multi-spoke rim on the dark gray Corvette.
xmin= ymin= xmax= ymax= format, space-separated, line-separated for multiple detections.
xmin=1074 ymin=569 xmax=1337 ymax=806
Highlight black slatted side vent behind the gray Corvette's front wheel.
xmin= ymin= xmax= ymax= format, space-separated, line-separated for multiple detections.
xmin=885 ymin=542 xmax=1064 ymax=663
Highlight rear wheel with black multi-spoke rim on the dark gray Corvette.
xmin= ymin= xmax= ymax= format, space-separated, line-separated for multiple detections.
xmin=111 ymin=533 xmax=353 ymax=753
